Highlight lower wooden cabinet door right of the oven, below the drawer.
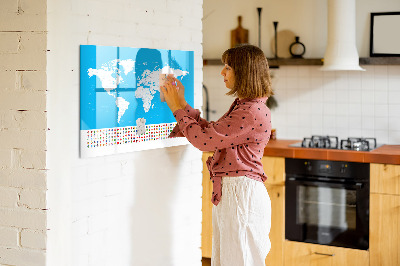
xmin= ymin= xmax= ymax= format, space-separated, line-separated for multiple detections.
xmin=369 ymin=194 xmax=400 ymax=266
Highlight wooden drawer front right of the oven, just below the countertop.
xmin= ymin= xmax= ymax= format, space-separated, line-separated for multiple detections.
xmin=370 ymin=163 xmax=400 ymax=195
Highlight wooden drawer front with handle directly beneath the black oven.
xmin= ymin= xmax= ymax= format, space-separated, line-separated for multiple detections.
xmin=284 ymin=240 xmax=369 ymax=266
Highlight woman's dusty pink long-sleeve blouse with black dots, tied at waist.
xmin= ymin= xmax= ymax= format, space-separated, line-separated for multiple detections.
xmin=170 ymin=97 xmax=271 ymax=205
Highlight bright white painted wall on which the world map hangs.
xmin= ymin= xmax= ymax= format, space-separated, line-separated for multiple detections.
xmin=46 ymin=0 xmax=203 ymax=266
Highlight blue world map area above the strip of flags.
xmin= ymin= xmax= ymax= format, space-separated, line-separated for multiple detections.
xmin=80 ymin=45 xmax=194 ymax=134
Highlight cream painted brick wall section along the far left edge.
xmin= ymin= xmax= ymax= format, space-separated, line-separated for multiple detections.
xmin=0 ymin=0 xmax=47 ymax=265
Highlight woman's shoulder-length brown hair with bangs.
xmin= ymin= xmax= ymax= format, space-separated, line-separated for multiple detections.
xmin=222 ymin=44 xmax=273 ymax=99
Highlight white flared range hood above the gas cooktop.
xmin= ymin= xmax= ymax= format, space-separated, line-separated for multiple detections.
xmin=320 ymin=0 xmax=365 ymax=71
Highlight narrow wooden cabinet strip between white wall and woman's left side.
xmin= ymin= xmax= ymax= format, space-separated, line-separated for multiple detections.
xmin=201 ymin=152 xmax=213 ymax=258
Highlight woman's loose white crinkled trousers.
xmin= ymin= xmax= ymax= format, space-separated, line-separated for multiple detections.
xmin=211 ymin=176 xmax=271 ymax=266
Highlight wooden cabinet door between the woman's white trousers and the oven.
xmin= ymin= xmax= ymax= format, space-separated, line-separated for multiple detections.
xmin=265 ymin=184 xmax=285 ymax=266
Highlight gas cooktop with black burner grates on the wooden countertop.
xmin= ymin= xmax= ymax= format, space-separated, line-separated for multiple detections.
xmin=289 ymin=135 xmax=380 ymax=151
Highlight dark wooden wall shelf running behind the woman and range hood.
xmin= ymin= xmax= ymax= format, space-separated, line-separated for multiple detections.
xmin=203 ymin=57 xmax=400 ymax=68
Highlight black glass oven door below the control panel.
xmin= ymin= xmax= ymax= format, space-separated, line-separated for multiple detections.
xmin=285 ymin=176 xmax=369 ymax=250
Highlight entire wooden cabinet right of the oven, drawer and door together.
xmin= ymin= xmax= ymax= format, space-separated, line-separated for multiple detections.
xmin=369 ymin=164 xmax=400 ymax=266
